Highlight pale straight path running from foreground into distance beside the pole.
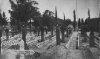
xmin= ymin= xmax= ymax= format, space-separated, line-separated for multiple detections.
xmin=66 ymin=32 xmax=95 ymax=59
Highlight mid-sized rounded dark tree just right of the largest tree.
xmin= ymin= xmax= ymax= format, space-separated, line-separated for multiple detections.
xmin=43 ymin=10 xmax=54 ymax=35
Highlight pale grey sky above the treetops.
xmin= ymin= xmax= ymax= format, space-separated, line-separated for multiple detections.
xmin=0 ymin=0 xmax=100 ymax=20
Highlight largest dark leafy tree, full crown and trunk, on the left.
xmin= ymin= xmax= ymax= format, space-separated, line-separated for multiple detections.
xmin=9 ymin=0 xmax=39 ymax=49
